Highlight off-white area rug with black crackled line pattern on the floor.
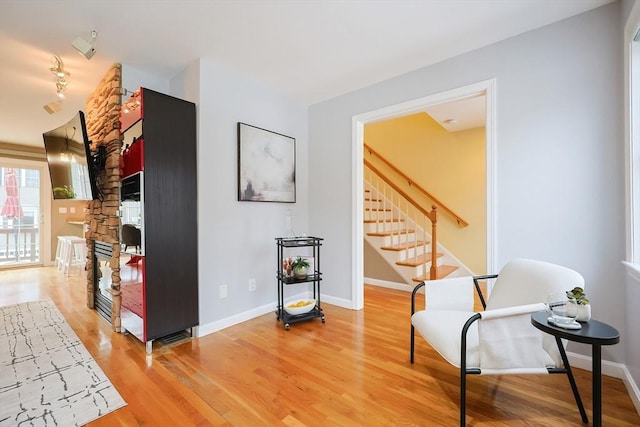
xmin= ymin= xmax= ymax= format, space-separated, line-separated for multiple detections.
xmin=0 ymin=300 xmax=126 ymax=427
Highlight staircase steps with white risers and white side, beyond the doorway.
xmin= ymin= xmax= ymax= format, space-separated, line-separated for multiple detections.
xmin=364 ymin=182 xmax=473 ymax=288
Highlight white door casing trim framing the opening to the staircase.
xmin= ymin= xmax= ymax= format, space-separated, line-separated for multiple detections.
xmin=352 ymin=79 xmax=496 ymax=310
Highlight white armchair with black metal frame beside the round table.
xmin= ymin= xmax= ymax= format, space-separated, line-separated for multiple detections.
xmin=411 ymin=259 xmax=588 ymax=426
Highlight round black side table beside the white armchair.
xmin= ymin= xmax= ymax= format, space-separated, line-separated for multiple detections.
xmin=531 ymin=311 xmax=620 ymax=427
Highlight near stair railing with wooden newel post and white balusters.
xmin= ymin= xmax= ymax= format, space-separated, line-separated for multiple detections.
xmin=364 ymin=159 xmax=438 ymax=280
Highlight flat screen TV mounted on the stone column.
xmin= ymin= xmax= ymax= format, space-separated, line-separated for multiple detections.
xmin=42 ymin=111 xmax=101 ymax=200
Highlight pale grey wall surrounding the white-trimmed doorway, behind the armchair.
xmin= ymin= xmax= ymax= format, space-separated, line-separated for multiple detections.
xmin=309 ymin=2 xmax=631 ymax=362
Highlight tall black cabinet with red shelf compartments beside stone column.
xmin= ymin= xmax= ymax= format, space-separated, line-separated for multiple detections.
xmin=121 ymin=88 xmax=199 ymax=352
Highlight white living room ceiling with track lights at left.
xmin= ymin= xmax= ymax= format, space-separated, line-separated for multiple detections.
xmin=0 ymin=0 xmax=613 ymax=145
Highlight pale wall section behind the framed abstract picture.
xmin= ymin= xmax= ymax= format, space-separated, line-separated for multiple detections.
xmin=191 ymin=59 xmax=311 ymax=333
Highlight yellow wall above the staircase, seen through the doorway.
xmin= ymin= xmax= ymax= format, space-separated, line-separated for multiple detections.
xmin=364 ymin=113 xmax=487 ymax=274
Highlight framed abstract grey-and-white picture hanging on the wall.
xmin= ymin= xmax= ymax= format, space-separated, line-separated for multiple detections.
xmin=238 ymin=122 xmax=296 ymax=203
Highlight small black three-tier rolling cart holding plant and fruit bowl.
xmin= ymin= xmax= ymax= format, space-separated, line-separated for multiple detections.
xmin=276 ymin=237 xmax=325 ymax=331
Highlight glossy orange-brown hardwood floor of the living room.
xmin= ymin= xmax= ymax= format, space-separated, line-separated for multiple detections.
xmin=0 ymin=267 xmax=640 ymax=427
